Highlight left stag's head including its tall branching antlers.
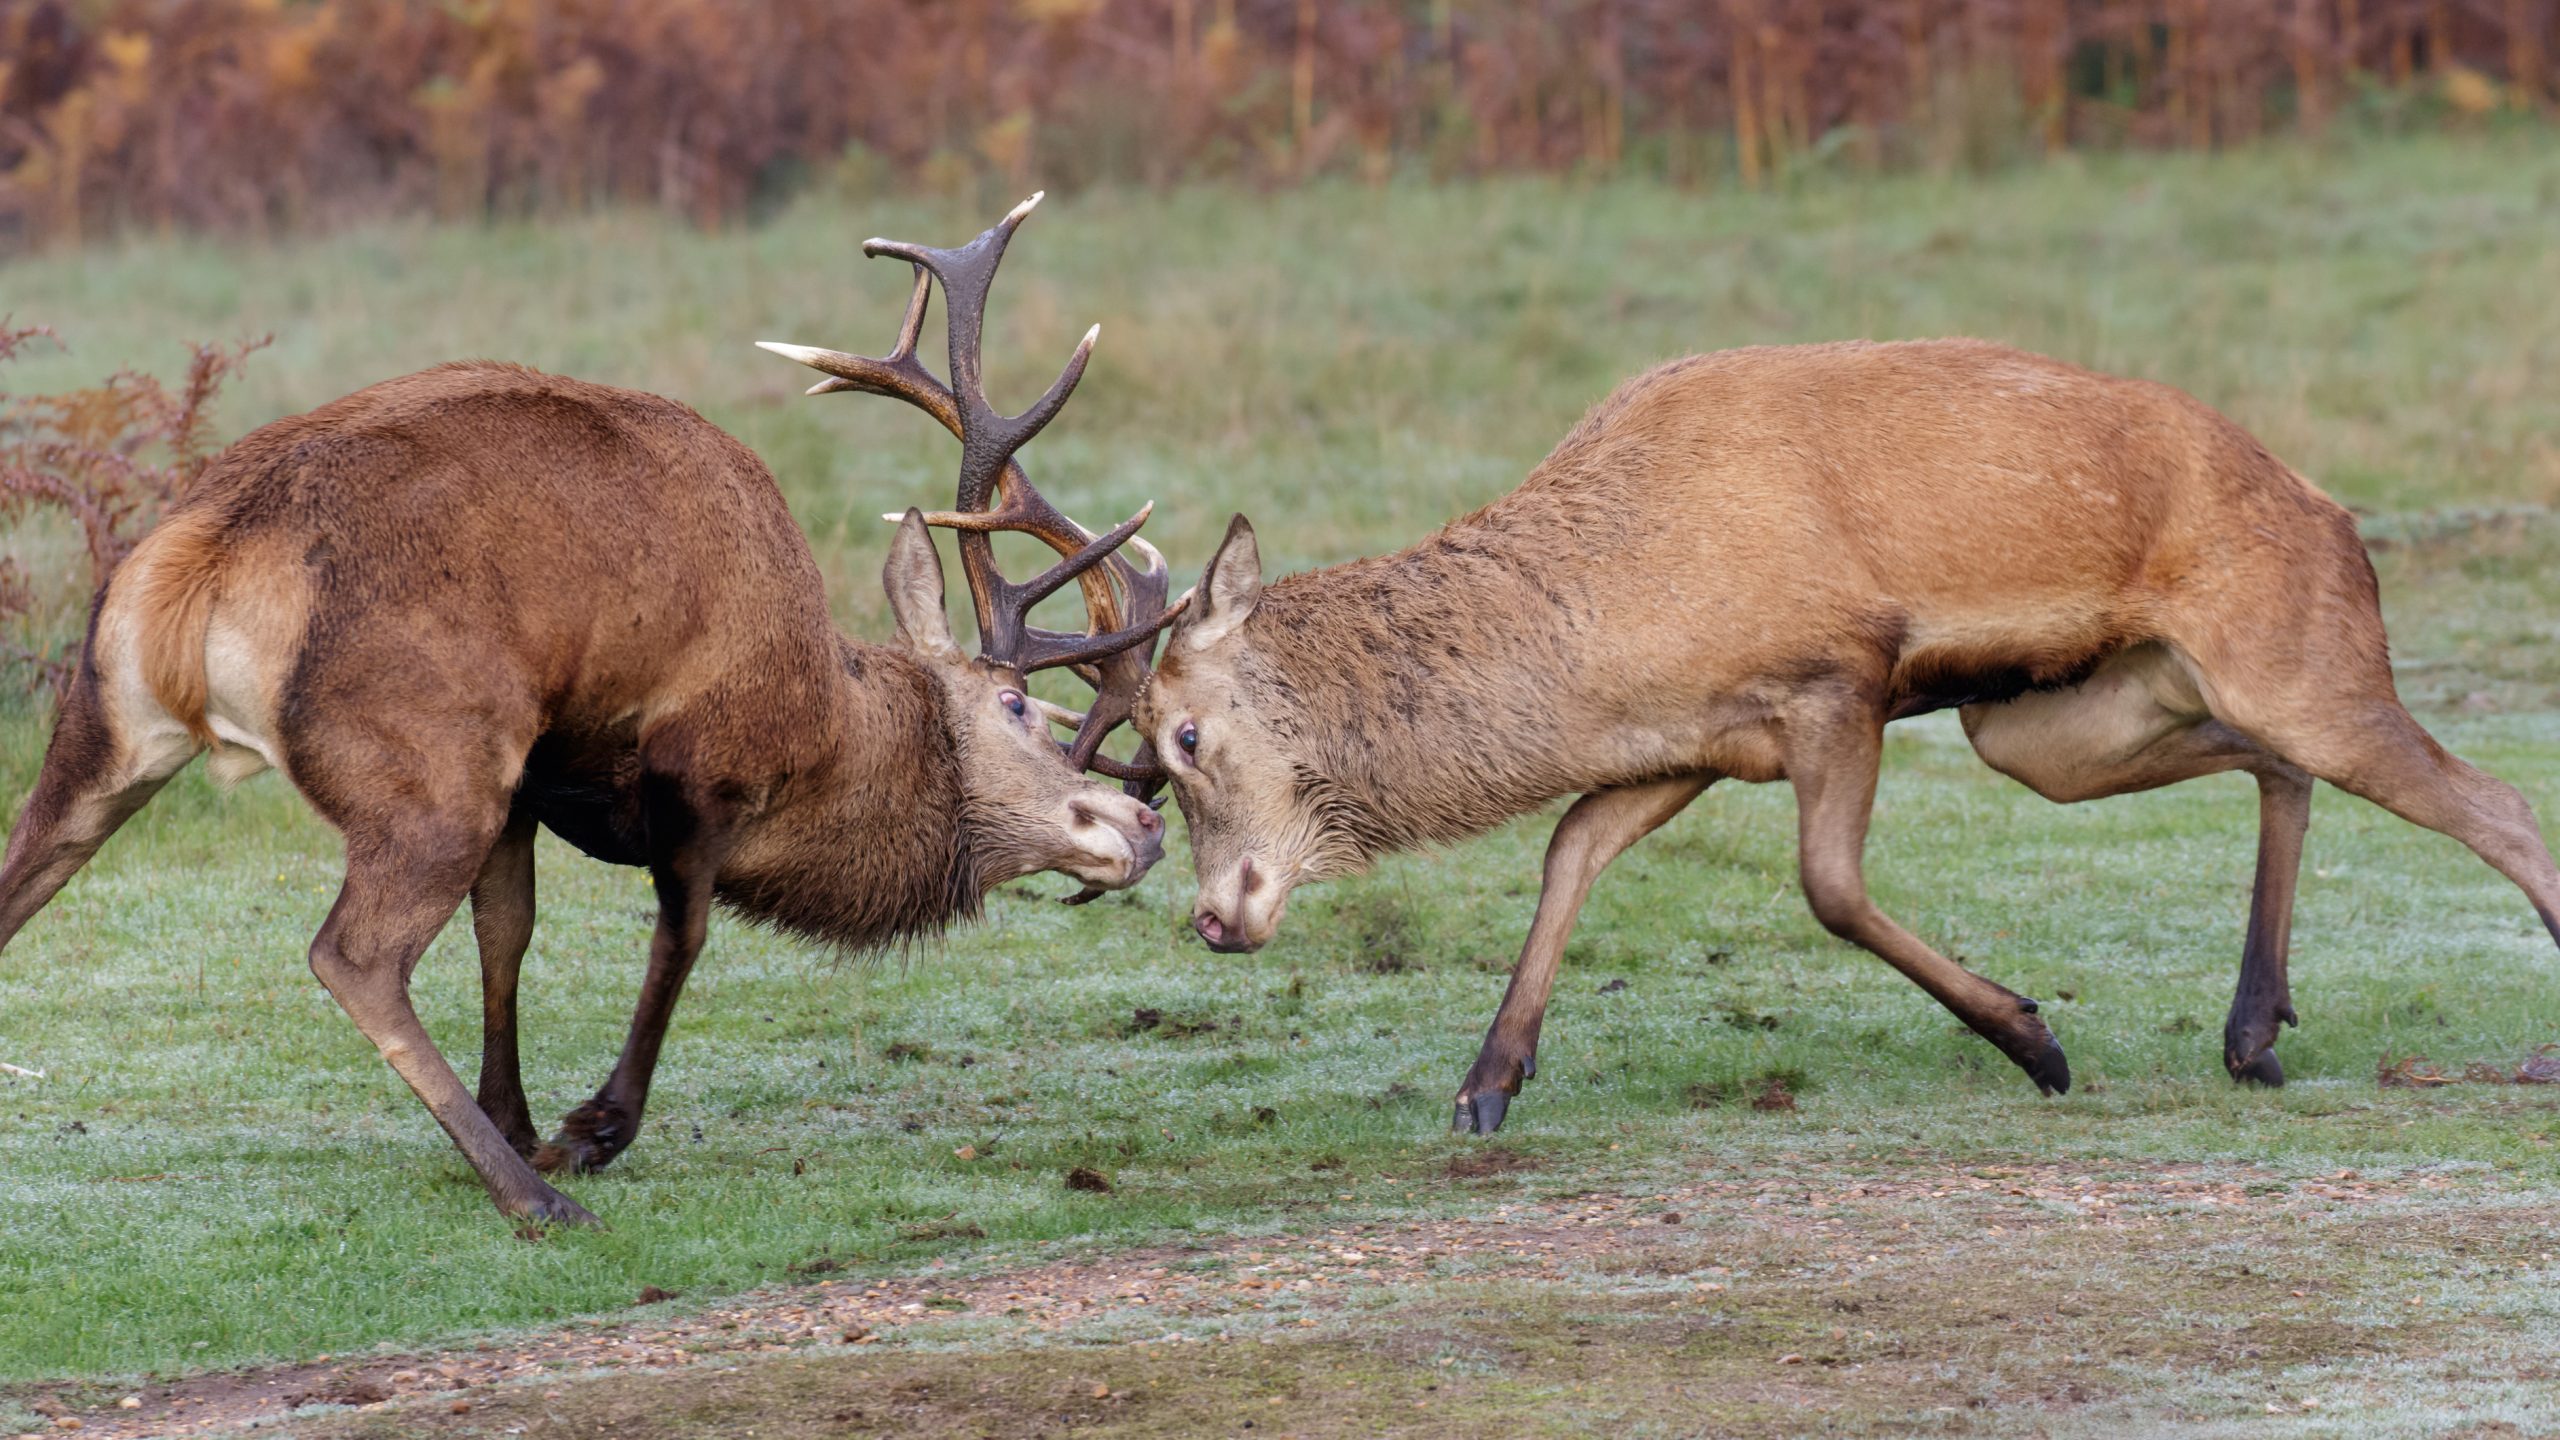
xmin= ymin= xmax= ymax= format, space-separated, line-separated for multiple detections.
xmin=763 ymin=195 xmax=1180 ymax=899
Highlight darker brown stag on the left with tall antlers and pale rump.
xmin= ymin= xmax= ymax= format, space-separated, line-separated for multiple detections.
xmin=0 ymin=196 xmax=1167 ymax=1222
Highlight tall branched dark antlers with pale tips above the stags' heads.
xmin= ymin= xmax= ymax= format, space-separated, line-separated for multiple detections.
xmin=758 ymin=195 xmax=1180 ymax=794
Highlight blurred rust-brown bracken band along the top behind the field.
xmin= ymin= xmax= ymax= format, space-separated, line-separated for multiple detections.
xmin=0 ymin=0 xmax=2560 ymax=246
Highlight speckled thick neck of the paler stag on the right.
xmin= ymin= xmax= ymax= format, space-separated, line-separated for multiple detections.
xmin=1247 ymin=505 xmax=1641 ymax=858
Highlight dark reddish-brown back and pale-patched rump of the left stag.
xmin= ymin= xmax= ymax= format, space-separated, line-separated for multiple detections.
xmin=97 ymin=361 xmax=835 ymax=771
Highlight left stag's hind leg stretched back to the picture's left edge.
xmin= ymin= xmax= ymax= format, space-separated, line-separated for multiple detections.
xmin=0 ymin=648 xmax=197 ymax=945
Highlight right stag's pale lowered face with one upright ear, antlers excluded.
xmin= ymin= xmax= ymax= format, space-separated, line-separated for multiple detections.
xmin=1137 ymin=515 xmax=1367 ymax=953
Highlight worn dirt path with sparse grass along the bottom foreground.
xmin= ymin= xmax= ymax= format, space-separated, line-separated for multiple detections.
xmin=18 ymin=1150 xmax=2555 ymax=1437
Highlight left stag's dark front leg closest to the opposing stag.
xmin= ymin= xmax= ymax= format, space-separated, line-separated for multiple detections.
xmin=532 ymin=779 xmax=727 ymax=1174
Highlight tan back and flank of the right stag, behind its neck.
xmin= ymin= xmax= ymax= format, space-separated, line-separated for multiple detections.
xmin=1449 ymin=341 xmax=2360 ymax=696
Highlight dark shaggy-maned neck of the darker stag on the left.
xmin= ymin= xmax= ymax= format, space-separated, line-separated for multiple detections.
xmin=719 ymin=641 xmax=988 ymax=951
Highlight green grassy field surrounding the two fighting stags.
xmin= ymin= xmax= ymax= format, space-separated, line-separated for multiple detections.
xmin=0 ymin=136 xmax=2560 ymax=1435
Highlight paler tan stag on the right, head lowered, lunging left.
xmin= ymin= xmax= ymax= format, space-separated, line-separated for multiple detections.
xmin=1137 ymin=341 xmax=2560 ymax=1133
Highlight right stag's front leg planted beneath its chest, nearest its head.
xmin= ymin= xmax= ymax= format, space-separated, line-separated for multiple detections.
xmin=1449 ymin=774 xmax=1715 ymax=1135
